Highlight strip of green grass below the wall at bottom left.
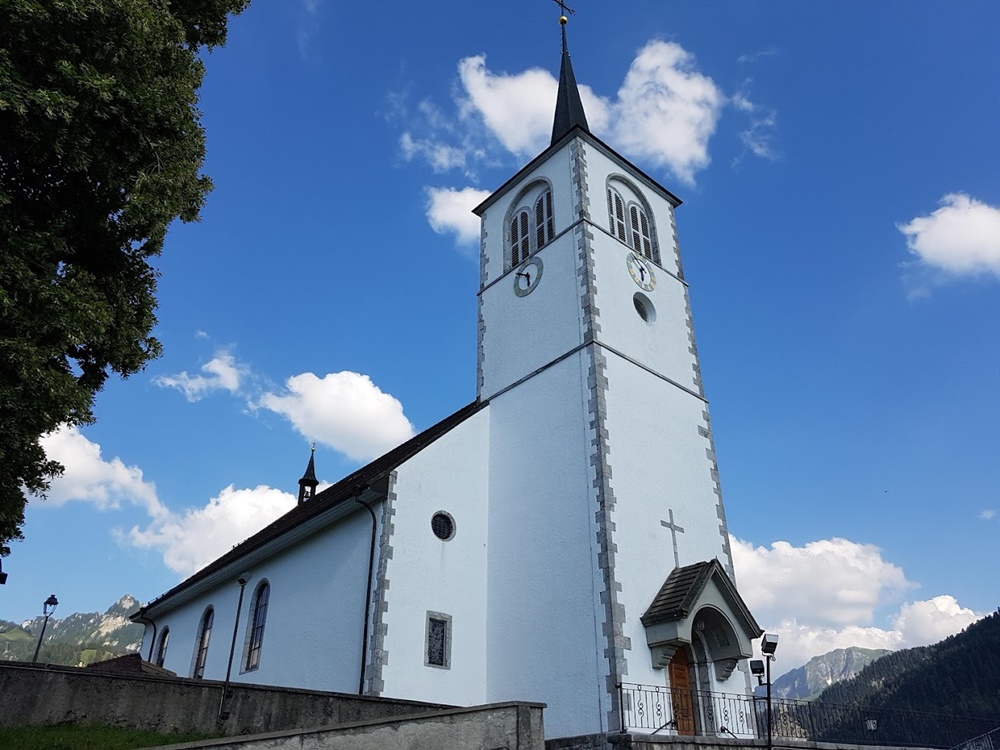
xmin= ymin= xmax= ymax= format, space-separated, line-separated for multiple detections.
xmin=0 ymin=724 xmax=217 ymax=750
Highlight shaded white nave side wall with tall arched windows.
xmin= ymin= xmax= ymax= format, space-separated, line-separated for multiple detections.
xmin=144 ymin=506 xmax=378 ymax=693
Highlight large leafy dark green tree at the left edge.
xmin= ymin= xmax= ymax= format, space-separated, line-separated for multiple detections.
xmin=0 ymin=0 xmax=249 ymax=556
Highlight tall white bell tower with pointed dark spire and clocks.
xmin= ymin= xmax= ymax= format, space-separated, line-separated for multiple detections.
xmin=475 ymin=16 xmax=759 ymax=736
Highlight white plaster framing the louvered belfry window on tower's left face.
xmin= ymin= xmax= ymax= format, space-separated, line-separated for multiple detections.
xmin=480 ymin=144 xmax=575 ymax=285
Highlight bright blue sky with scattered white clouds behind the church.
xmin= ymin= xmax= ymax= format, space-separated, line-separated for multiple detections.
xmin=0 ymin=0 xmax=1000 ymax=671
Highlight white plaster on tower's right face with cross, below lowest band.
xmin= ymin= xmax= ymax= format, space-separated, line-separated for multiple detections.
xmin=606 ymin=355 xmax=731 ymax=691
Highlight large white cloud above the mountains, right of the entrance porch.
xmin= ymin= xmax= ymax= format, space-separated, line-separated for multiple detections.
xmin=730 ymin=537 xmax=983 ymax=673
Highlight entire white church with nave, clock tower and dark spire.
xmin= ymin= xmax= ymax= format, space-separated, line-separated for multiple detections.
xmin=133 ymin=17 xmax=762 ymax=738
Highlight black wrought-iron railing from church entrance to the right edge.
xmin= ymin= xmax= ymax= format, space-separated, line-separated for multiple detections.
xmin=619 ymin=683 xmax=1000 ymax=750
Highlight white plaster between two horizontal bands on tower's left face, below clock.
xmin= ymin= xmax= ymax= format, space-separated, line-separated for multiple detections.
xmin=480 ymin=236 xmax=584 ymax=400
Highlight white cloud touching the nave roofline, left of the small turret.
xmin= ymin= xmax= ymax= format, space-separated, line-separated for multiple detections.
xmin=126 ymin=485 xmax=296 ymax=576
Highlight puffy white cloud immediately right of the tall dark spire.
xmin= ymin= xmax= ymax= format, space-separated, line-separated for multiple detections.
xmin=612 ymin=41 xmax=725 ymax=183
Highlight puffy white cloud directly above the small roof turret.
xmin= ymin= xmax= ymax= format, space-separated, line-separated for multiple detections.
xmin=258 ymin=371 xmax=413 ymax=461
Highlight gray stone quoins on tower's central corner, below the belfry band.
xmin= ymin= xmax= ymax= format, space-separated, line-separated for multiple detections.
xmin=575 ymin=214 xmax=632 ymax=729
